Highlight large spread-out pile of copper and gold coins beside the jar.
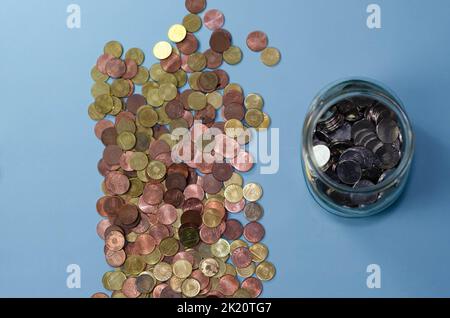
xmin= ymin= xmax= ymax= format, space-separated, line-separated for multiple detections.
xmin=89 ymin=0 xmax=275 ymax=298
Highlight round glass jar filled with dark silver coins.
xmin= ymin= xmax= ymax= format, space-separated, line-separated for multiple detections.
xmin=302 ymin=79 xmax=414 ymax=217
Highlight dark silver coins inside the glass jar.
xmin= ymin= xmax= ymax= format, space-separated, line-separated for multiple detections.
xmin=313 ymin=96 xmax=403 ymax=208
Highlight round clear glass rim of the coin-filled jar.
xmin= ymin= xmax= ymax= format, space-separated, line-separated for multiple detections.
xmin=303 ymin=77 xmax=415 ymax=194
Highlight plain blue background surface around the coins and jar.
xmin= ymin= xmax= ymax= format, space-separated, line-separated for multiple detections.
xmin=0 ymin=0 xmax=450 ymax=297
